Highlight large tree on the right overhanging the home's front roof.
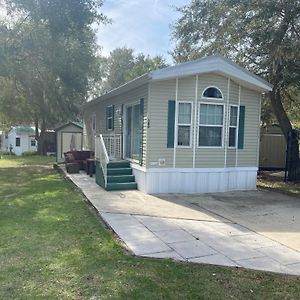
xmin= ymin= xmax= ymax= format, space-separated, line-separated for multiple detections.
xmin=172 ymin=0 xmax=300 ymax=142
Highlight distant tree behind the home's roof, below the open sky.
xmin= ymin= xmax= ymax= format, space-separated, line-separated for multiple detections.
xmin=102 ymin=47 xmax=167 ymax=92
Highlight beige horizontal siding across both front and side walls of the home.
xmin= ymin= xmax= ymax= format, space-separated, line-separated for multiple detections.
xmin=84 ymin=73 xmax=260 ymax=168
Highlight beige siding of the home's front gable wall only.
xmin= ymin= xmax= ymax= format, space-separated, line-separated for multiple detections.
xmin=147 ymin=73 xmax=260 ymax=168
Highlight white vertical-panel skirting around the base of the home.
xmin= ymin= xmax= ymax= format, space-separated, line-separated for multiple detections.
xmin=131 ymin=163 xmax=257 ymax=194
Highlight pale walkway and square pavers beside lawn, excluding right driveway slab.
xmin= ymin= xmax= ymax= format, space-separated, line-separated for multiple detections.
xmin=67 ymin=173 xmax=300 ymax=275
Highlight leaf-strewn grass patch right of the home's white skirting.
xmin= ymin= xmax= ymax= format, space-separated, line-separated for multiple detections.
xmin=257 ymin=171 xmax=300 ymax=198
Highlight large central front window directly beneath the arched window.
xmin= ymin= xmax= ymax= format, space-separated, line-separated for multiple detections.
xmin=198 ymin=103 xmax=224 ymax=147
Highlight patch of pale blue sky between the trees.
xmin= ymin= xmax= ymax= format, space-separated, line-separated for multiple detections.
xmin=97 ymin=0 xmax=190 ymax=63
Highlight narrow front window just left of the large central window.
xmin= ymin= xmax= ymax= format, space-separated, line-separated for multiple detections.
xmin=177 ymin=102 xmax=192 ymax=147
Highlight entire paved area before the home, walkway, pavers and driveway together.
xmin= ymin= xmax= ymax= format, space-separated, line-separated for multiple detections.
xmin=68 ymin=174 xmax=300 ymax=275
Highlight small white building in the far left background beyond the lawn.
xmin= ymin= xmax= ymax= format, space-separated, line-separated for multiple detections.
xmin=6 ymin=126 xmax=37 ymax=155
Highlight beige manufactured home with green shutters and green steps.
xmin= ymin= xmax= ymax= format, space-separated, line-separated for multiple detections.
xmin=83 ymin=56 xmax=272 ymax=193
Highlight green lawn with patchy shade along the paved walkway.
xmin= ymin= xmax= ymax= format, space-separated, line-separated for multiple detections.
xmin=0 ymin=157 xmax=300 ymax=300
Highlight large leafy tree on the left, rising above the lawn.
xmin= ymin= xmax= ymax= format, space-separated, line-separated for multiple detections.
xmin=0 ymin=0 xmax=105 ymax=153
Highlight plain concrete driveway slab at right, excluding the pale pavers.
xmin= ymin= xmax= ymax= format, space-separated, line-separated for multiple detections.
xmin=159 ymin=190 xmax=300 ymax=251
